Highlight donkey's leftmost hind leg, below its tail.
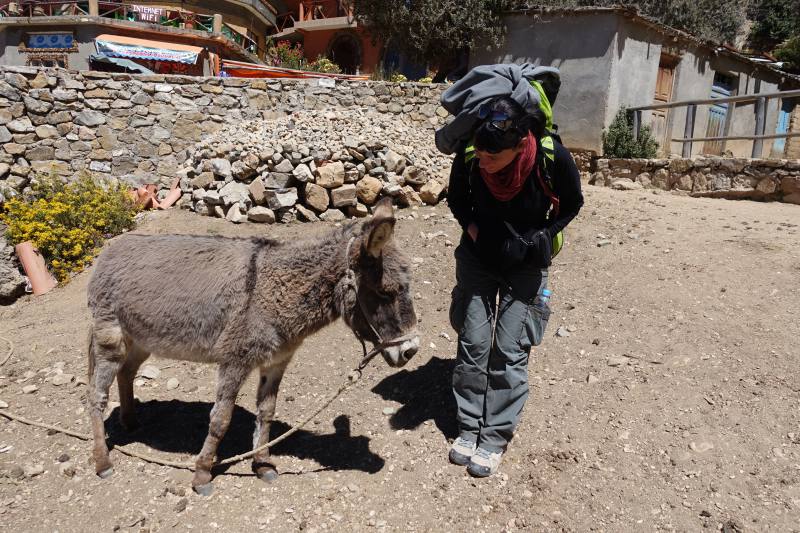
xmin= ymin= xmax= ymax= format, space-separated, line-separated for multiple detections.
xmin=87 ymin=324 xmax=125 ymax=478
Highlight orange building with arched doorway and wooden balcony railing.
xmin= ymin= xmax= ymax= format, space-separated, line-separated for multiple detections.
xmin=270 ymin=0 xmax=382 ymax=74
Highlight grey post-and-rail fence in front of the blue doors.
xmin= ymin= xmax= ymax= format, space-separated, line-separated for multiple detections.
xmin=628 ymin=90 xmax=800 ymax=159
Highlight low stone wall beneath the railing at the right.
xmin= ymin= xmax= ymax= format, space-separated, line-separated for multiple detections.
xmin=589 ymin=157 xmax=800 ymax=204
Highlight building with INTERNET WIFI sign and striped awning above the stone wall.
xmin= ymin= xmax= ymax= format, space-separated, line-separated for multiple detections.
xmin=0 ymin=0 xmax=286 ymax=75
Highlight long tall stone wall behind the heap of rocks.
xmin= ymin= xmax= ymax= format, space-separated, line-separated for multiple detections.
xmin=0 ymin=67 xmax=447 ymax=203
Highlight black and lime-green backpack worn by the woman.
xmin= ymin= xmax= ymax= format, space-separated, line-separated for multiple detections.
xmin=464 ymin=72 xmax=564 ymax=257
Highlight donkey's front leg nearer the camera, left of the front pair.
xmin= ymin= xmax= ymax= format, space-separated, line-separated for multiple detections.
xmin=192 ymin=363 xmax=250 ymax=496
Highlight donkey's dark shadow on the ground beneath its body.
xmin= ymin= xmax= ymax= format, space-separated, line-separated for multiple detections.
xmin=106 ymin=400 xmax=385 ymax=473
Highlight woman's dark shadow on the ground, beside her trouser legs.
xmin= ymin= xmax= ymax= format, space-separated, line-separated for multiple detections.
xmin=372 ymin=357 xmax=458 ymax=439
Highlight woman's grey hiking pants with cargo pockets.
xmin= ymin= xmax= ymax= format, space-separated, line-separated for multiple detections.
xmin=450 ymin=242 xmax=550 ymax=452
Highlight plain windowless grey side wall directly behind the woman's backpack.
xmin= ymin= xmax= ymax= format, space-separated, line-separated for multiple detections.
xmin=470 ymin=15 xmax=618 ymax=152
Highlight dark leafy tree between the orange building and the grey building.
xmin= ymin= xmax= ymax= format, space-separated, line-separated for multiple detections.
xmin=353 ymin=0 xmax=511 ymax=81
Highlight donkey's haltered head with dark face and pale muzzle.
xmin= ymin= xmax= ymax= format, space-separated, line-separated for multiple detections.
xmin=340 ymin=199 xmax=419 ymax=366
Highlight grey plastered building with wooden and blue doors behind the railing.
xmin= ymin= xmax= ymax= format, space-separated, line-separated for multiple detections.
xmin=470 ymin=7 xmax=800 ymax=156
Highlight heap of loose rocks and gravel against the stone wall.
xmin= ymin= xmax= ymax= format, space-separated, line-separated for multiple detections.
xmin=179 ymin=110 xmax=451 ymax=223
